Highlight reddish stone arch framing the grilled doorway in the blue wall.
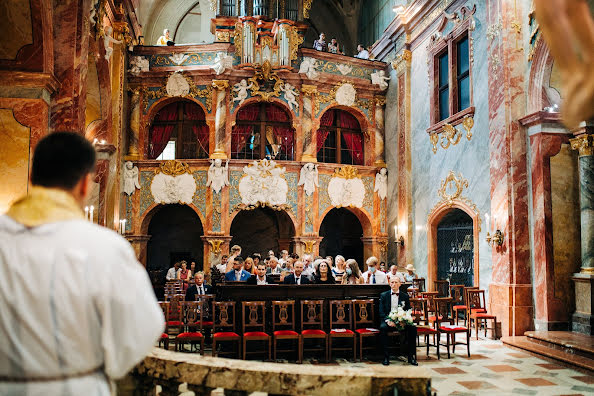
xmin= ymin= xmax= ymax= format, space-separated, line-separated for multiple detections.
xmin=426 ymin=199 xmax=480 ymax=290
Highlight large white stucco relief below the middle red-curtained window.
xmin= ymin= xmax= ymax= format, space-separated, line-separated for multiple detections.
xmin=238 ymin=159 xmax=289 ymax=206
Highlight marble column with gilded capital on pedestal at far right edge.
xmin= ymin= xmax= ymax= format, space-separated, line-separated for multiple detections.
xmin=570 ymin=134 xmax=594 ymax=335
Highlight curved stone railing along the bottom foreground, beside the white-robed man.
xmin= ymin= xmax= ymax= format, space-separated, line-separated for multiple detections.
xmin=118 ymin=348 xmax=431 ymax=396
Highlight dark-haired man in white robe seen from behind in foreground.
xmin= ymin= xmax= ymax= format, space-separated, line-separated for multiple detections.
xmin=0 ymin=132 xmax=164 ymax=396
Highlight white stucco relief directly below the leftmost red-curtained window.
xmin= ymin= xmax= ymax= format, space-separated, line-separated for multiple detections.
xmin=151 ymin=173 xmax=196 ymax=204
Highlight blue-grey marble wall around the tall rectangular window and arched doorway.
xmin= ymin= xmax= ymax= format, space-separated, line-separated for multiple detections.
xmin=386 ymin=2 xmax=492 ymax=290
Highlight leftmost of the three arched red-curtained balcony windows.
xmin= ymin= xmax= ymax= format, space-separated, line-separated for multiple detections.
xmin=148 ymin=101 xmax=209 ymax=160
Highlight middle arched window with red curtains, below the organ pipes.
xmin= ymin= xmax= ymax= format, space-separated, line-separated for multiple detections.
xmin=231 ymin=102 xmax=294 ymax=161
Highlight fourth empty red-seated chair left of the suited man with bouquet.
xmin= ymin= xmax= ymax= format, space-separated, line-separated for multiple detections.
xmin=272 ymin=300 xmax=302 ymax=363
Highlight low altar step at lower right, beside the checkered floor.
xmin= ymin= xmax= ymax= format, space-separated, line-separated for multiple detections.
xmin=501 ymin=331 xmax=594 ymax=372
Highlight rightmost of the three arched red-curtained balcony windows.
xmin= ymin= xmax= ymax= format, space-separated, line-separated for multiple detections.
xmin=317 ymin=109 xmax=364 ymax=165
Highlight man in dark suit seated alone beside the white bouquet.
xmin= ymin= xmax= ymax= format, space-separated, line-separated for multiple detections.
xmin=380 ymin=276 xmax=417 ymax=366
